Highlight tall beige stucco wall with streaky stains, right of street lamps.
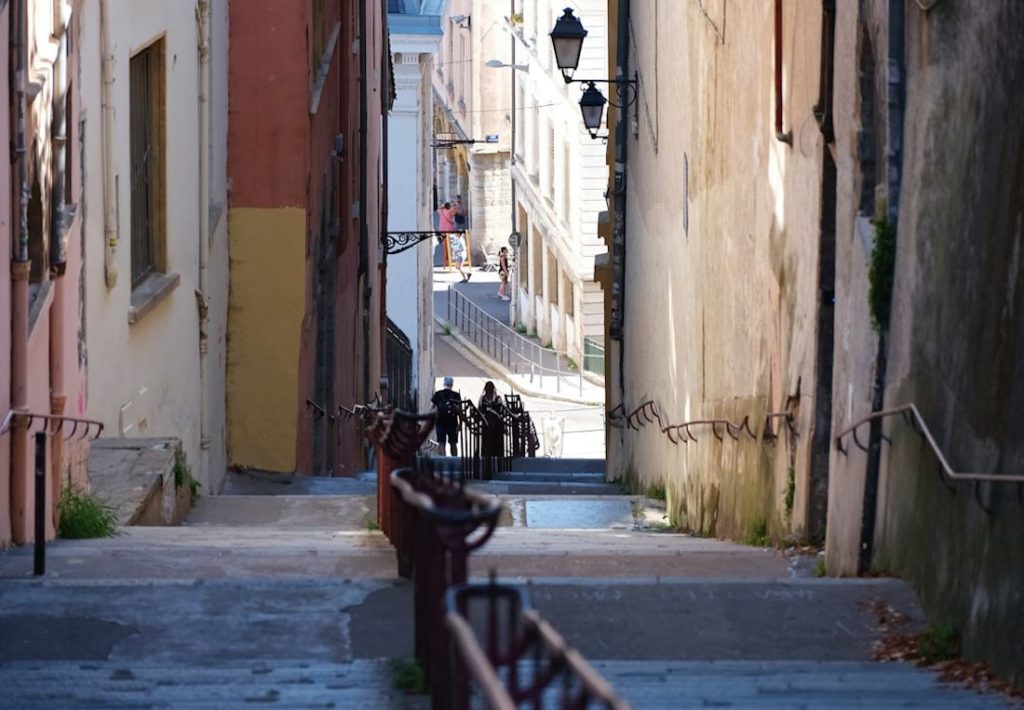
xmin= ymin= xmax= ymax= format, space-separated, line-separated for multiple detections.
xmin=608 ymin=0 xmax=822 ymax=538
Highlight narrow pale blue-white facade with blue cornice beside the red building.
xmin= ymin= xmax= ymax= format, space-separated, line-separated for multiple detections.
xmin=387 ymin=0 xmax=444 ymax=411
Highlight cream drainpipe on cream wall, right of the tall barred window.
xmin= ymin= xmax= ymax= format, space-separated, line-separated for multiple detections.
xmin=196 ymin=0 xmax=210 ymax=451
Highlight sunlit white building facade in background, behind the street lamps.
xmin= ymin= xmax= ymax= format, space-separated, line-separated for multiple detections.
xmin=506 ymin=0 xmax=608 ymax=364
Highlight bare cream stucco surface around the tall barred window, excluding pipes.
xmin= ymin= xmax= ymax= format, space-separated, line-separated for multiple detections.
xmin=77 ymin=0 xmax=227 ymax=492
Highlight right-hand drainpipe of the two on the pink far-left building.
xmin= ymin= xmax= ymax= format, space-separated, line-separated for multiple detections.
xmin=50 ymin=1 xmax=71 ymax=523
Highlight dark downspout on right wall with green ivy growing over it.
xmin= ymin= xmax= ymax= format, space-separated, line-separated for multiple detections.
xmin=857 ymin=0 xmax=906 ymax=575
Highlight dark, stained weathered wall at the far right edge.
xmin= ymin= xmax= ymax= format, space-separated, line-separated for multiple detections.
xmin=876 ymin=0 xmax=1024 ymax=680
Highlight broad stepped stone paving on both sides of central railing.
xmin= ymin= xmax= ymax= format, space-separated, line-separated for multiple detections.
xmin=0 ymin=473 xmax=998 ymax=709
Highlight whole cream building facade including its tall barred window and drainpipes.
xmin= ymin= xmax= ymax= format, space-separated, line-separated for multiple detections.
xmin=77 ymin=0 xmax=228 ymax=493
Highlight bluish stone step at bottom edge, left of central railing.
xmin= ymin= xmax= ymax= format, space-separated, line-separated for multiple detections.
xmin=0 ymin=659 xmax=430 ymax=710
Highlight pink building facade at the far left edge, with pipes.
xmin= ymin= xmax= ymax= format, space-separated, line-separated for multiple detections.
xmin=0 ymin=0 xmax=88 ymax=547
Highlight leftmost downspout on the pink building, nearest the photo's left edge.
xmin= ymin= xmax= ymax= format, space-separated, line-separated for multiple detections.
xmin=10 ymin=0 xmax=32 ymax=543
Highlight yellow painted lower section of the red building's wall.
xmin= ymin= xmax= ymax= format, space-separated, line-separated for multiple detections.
xmin=227 ymin=208 xmax=306 ymax=471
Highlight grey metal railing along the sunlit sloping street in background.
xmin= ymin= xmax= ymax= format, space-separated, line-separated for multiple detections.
xmin=447 ymin=287 xmax=584 ymax=395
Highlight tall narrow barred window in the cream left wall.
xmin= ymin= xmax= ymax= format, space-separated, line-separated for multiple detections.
xmin=129 ymin=40 xmax=165 ymax=286
